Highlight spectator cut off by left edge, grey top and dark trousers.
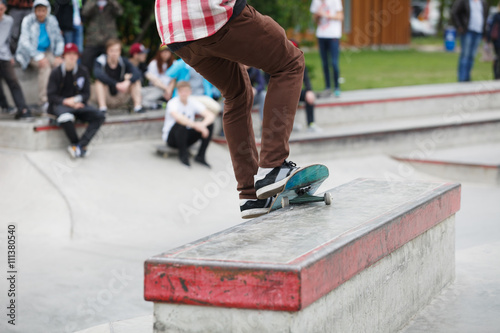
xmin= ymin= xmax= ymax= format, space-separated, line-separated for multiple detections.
xmin=0 ymin=0 xmax=31 ymax=119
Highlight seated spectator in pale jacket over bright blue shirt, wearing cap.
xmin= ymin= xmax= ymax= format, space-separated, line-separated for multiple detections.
xmin=16 ymin=0 xmax=64 ymax=107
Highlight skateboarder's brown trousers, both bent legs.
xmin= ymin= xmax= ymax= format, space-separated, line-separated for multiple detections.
xmin=176 ymin=6 xmax=304 ymax=199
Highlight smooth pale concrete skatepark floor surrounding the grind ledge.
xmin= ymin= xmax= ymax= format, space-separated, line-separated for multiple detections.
xmin=0 ymin=137 xmax=500 ymax=332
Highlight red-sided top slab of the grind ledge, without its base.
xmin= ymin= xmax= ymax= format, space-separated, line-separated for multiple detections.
xmin=144 ymin=179 xmax=460 ymax=311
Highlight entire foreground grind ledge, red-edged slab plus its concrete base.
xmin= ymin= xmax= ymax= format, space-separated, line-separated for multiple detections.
xmin=144 ymin=179 xmax=460 ymax=332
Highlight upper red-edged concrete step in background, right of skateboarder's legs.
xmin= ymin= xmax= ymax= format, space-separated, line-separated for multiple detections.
xmin=252 ymin=81 xmax=500 ymax=133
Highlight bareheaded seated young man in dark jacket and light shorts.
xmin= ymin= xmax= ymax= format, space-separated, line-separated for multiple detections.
xmin=92 ymin=39 xmax=144 ymax=113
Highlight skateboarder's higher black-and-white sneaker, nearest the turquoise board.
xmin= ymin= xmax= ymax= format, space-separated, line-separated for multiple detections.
xmin=254 ymin=161 xmax=300 ymax=199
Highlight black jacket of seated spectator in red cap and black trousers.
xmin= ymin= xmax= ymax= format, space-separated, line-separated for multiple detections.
xmin=47 ymin=64 xmax=90 ymax=113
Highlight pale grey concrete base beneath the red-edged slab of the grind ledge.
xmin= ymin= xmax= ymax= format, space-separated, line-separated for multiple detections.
xmin=155 ymin=217 xmax=455 ymax=333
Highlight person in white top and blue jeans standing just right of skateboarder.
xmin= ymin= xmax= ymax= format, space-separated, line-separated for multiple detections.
xmin=310 ymin=0 xmax=344 ymax=97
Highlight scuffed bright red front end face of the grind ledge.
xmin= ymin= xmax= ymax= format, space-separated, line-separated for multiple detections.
xmin=144 ymin=263 xmax=300 ymax=311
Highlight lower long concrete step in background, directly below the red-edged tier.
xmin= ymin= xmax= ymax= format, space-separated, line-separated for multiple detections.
xmin=214 ymin=110 xmax=500 ymax=157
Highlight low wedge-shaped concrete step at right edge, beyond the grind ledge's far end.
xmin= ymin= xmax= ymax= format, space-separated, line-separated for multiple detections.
xmin=393 ymin=143 xmax=500 ymax=185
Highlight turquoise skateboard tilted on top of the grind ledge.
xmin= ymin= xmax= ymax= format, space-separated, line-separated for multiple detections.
xmin=269 ymin=164 xmax=332 ymax=212
